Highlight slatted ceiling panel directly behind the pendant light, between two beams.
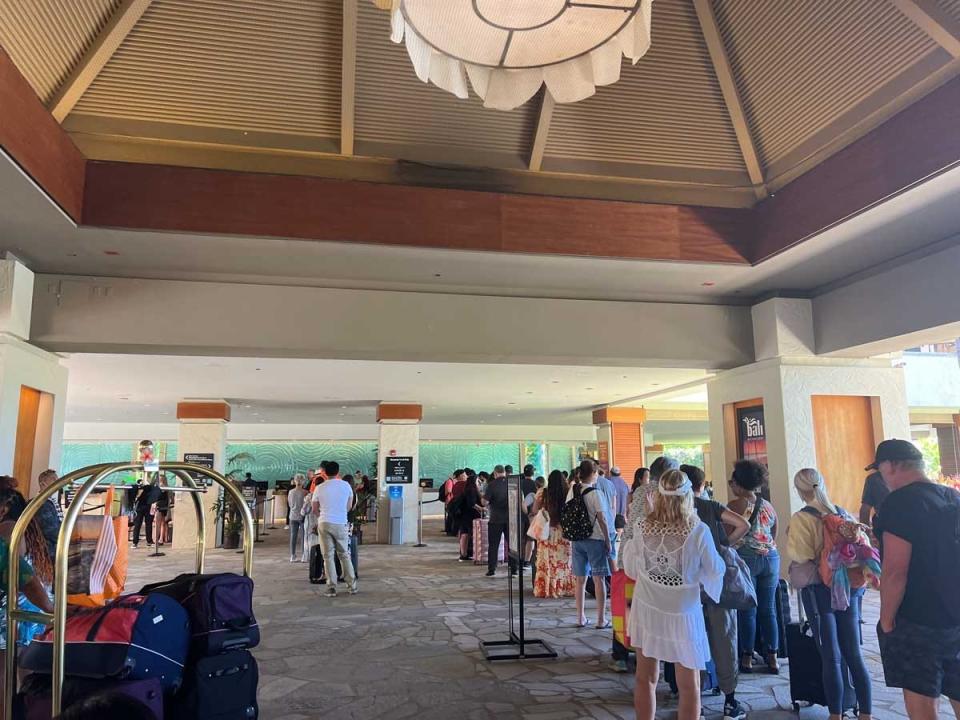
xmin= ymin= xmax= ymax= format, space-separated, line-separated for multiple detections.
xmin=356 ymin=0 xmax=536 ymax=166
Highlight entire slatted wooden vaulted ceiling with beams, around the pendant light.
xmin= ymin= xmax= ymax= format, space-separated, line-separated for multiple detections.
xmin=0 ymin=0 xmax=960 ymax=207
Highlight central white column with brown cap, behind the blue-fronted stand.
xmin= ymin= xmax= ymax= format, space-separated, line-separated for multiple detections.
xmin=377 ymin=403 xmax=423 ymax=544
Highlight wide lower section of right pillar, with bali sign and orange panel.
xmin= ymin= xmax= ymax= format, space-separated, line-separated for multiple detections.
xmin=707 ymin=357 xmax=910 ymax=537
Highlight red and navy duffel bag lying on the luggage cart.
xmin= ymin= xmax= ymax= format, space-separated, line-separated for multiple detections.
xmin=20 ymin=593 xmax=190 ymax=692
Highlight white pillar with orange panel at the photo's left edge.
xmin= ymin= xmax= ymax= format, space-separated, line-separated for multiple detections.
xmin=0 ymin=258 xmax=67 ymax=495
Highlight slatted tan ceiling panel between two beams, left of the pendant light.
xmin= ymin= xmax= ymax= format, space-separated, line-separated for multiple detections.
xmin=75 ymin=0 xmax=342 ymax=137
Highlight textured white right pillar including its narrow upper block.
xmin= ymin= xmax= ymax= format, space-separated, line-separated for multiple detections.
xmin=707 ymin=298 xmax=910 ymax=536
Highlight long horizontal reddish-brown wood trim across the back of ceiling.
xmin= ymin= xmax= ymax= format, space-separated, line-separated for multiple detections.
xmin=84 ymin=161 xmax=750 ymax=263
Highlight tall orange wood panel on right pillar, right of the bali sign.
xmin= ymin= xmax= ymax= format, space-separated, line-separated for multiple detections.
xmin=811 ymin=395 xmax=876 ymax=515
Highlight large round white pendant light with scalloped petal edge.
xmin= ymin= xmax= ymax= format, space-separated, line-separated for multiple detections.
xmin=374 ymin=0 xmax=652 ymax=110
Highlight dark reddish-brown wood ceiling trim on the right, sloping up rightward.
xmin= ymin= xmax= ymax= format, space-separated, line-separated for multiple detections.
xmin=751 ymin=73 xmax=960 ymax=263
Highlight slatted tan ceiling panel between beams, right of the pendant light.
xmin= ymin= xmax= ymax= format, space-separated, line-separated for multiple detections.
xmin=546 ymin=0 xmax=744 ymax=171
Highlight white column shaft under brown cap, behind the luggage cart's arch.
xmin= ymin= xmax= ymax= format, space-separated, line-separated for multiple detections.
xmin=173 ymin=408 xmax=227 ymax=548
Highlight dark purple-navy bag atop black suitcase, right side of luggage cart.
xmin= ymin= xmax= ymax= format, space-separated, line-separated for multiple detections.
xmin=140 ymin=573 xmax=260 ymax=657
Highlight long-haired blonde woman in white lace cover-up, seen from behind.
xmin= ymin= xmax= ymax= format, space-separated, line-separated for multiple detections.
xmin=623 ymin=470 xmax=725 ymax=720
